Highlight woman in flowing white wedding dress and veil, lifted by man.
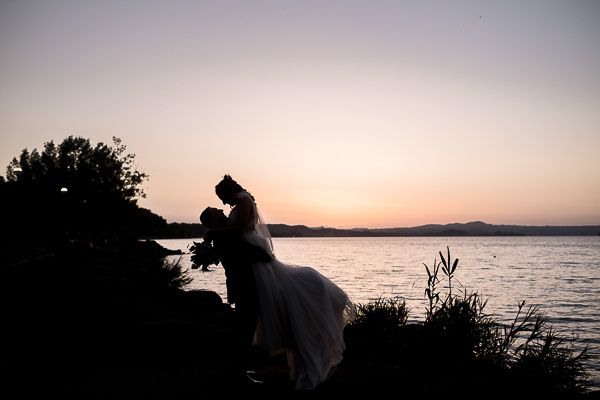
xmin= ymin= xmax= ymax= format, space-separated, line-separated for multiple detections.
xmin=215 ymin=175 xmax=354 ymax=390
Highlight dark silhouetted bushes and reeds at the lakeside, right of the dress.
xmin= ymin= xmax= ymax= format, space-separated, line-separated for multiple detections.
xmin=343 ymin=248 xmax=590 ymax=398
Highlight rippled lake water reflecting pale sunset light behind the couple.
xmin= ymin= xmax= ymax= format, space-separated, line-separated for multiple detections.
xmin=158 ymin=236 xmax=600 ymax=389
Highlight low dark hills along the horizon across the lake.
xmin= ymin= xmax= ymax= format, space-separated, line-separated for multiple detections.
xmin=155 ymin=221 xmax=600 ymax=238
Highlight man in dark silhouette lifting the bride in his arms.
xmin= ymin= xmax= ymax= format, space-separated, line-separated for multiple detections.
xmin=200 ymin=207 xmax=271 ymax=380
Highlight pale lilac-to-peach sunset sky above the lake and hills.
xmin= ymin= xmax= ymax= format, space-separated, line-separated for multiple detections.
xmin=0 ymin=0 xmax=600 ymax=228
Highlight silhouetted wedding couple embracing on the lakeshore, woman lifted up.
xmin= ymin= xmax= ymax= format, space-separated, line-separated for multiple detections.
xmin=200 ymin=175 xmax=354 ymax=390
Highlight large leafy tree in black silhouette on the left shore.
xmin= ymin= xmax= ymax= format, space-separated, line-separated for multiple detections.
xmin=0 ymin=136 xmax=166 ymax=250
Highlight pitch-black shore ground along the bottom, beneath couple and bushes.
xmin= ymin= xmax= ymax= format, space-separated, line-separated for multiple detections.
xmin=0 ymin=242 xmax=600 ymax=399
